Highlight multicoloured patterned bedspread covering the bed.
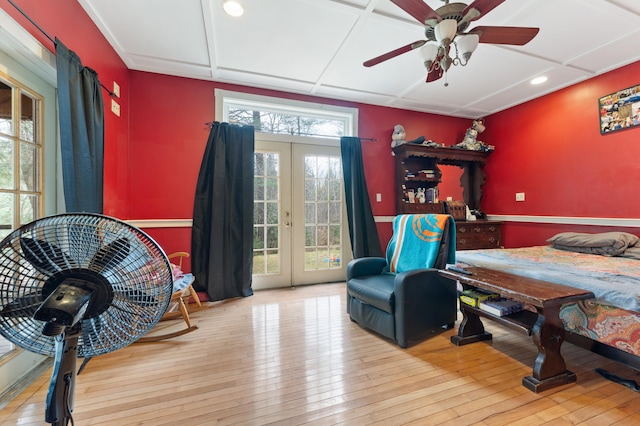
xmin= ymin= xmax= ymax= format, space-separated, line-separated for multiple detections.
xmin=456 ymin=246 xmax=640 ymax=355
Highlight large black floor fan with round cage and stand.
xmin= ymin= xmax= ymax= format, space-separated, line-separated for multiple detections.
xmin=0 ymin=213 xmax=173 ymax=426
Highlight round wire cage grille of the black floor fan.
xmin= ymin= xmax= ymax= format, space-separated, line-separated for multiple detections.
xmin=0 ymin=213 xmax=173 ymax=357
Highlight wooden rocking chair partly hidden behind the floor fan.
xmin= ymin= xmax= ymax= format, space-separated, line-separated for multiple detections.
xmin=137 ymin=251 xmax=203 ymax=343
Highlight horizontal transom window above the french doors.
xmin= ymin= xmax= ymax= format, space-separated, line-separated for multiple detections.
xmin=216 ymin=90 xmax=358 ymax=139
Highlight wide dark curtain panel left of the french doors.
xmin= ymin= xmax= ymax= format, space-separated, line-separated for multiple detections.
xmin=191 ymin=122 xmax=255 ymax=300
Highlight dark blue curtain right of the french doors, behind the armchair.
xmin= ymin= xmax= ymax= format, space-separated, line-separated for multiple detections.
xmin=340 ymin=136 xmax=382 ymax=259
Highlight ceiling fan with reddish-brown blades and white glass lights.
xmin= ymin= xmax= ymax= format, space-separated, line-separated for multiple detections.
xmin=363 ymin=0 xmax=540 ymax=86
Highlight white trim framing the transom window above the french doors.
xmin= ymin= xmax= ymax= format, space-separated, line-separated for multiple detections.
xmin=214 ymin=89 xmax=358 ymax=146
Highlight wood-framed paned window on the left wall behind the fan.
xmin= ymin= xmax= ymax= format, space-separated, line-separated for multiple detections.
xmin=0 ymin=75 xmax=43 ymax=239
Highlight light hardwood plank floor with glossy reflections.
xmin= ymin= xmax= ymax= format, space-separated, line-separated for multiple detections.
xmin=0 ymin=283 xmax=640 ymax=426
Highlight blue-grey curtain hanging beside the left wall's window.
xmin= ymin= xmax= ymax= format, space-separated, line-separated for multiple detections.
xmin=55 ymin=39 xmax=104 ymax=213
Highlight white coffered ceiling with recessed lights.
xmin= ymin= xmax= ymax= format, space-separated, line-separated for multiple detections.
xmin=79 ymin=0 xmax=640 ymax=118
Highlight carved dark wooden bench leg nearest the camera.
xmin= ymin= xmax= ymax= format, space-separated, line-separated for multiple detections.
xmin=522 ymin=305 xmax=576 ymax=393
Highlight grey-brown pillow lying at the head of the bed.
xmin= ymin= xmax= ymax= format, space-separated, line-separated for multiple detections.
xmin=547 ymin=232 xmax=640 ymax=256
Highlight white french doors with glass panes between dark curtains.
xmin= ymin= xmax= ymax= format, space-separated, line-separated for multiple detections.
xmin=253 ymin=140 xmax=351 ymax=290
